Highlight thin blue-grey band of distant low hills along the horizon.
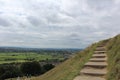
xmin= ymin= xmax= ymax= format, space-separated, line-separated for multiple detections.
xmin=0 ymin=46 xmax=83 ymax=52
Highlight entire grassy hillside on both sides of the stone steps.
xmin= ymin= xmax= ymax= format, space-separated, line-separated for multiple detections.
xmin=32 ymin=35 xmax=120 ymax=80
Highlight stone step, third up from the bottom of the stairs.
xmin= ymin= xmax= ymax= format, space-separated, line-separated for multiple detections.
xmin=85 ymin=62 xmax=107 ymax=68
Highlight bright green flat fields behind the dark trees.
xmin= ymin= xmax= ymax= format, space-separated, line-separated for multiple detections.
xmin=0 ymin=52 xmax=63 ymax=64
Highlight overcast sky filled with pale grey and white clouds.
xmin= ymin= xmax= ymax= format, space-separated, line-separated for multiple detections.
xmin=0 ymin=0 xmax=120 ymax=48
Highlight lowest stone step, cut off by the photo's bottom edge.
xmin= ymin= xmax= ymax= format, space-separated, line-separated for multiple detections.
xmin=74 ymin=75 xmax=105 ymax=80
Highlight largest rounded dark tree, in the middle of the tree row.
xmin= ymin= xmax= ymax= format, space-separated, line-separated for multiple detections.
xmin=20 ymin=62 xmax=41 ymax=76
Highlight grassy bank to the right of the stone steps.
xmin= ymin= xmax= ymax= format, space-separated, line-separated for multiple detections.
xmin=107 ymin=35 xmax=120 ymax=80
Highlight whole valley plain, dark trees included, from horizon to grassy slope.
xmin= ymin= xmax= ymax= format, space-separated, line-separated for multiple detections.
xmin=0 ymin=47 xmax=81 ymax=80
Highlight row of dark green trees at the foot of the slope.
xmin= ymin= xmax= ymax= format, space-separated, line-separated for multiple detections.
xmin=0 ymin=61 xmax=55 ymax=80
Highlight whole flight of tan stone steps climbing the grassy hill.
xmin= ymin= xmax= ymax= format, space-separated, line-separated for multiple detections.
xmin=74 ymin=45 xmax=107 ymax=80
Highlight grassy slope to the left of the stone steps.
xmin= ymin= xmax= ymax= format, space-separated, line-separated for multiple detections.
xmin=32 ymin=44 xmax=97 ymax=80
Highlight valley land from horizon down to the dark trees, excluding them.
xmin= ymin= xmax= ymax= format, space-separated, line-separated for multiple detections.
xmin=0 ymin=48 xmax=80 ymax=64
